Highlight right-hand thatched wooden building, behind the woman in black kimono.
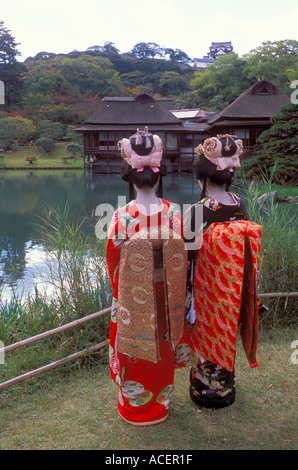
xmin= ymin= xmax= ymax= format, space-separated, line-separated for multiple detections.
xmin=208 ymin=80 xmax=290 ymax=150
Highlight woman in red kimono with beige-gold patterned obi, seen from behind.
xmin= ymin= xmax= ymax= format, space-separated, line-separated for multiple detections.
xmin=107 ymin=128 xmax=198 ymax=425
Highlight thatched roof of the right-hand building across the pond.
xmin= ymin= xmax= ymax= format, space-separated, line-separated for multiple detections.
xmin=208 ymin=80 xmax=290 ymax=125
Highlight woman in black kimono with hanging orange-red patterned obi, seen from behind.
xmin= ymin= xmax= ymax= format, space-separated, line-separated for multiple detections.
xmin=185 ymin=135 xmax=262 ymax=408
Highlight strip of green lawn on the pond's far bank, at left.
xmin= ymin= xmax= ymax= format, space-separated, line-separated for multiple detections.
xmin=0 ymin=142 xmax=84 ymax=169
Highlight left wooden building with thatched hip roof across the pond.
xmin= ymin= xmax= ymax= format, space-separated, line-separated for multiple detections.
xmin=76 ymin=93 xmax=209 ymax=173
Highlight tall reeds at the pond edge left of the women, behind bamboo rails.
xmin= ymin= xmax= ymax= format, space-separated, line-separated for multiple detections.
xmin=0 ymin=203 xmax=112 ymax=388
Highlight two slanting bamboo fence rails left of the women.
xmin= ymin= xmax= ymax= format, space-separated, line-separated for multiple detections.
xmin=0 ymin=307 xmax=111 ymax=390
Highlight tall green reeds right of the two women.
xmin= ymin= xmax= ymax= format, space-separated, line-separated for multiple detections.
xmin=239 ymin=171 xmax=297 ymax=328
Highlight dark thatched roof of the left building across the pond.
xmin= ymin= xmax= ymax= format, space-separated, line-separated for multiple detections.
xmin=85 ymin=93 xmax=182 ymax=128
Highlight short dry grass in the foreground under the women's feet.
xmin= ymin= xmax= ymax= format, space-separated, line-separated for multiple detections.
xmin=0 ymin=330 xmax=298 ymax=450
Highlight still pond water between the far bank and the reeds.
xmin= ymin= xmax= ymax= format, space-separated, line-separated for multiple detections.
xmin=0 ymin=170 xmax=200 ymax=301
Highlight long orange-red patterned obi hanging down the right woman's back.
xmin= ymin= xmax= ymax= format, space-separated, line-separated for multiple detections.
xmin=193 ymin=220 xmax=262 ymax=371
